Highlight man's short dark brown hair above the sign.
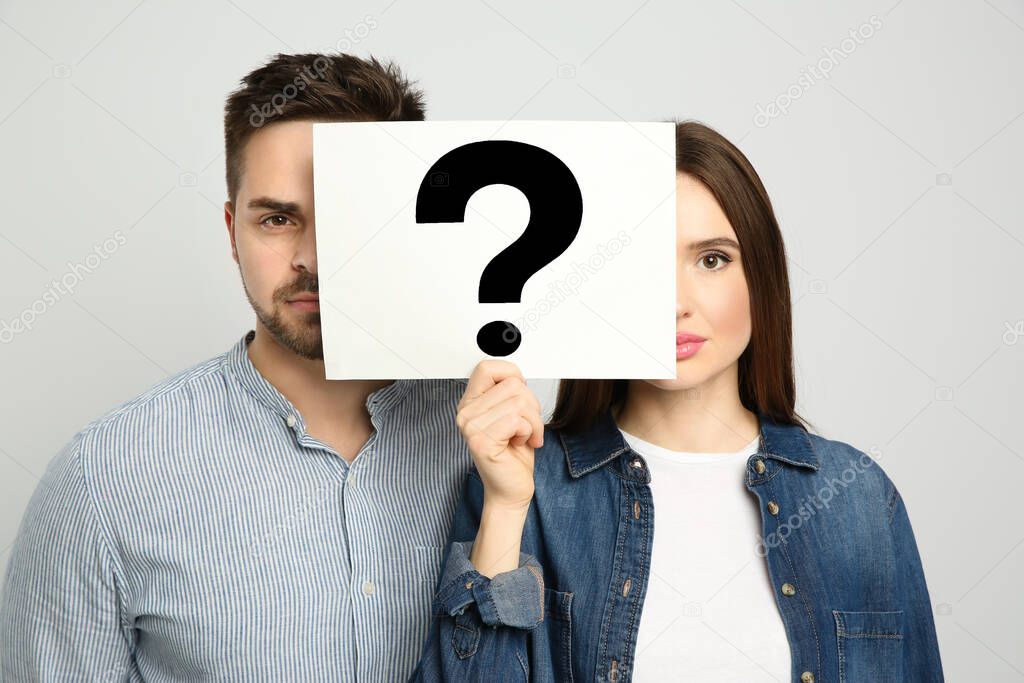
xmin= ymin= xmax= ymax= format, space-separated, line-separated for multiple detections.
xmin=224 ymin=53 xmax=424 ymax=202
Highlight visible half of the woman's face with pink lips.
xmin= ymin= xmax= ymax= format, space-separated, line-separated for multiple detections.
xmin=646 ymin=174 xmax=751 ymax=390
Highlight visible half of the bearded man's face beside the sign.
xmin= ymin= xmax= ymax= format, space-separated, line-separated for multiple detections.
xmin=224 ymin=121 xmax=324 ymax=360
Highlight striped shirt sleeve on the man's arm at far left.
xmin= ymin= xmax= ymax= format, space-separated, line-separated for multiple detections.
xmin=0 ymin=432 xmax=137 ymax=682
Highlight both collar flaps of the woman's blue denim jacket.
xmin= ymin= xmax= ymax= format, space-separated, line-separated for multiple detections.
xmin=558 ymin=409 xmax=820 ymax=479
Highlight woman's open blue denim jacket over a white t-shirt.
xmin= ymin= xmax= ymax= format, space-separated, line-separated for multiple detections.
xmin=413 ymin=412 xmax=943 ymax=683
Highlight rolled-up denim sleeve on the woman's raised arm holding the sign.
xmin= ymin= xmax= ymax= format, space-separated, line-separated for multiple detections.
xmin=410 ymin=471 xmax=544 ymax=682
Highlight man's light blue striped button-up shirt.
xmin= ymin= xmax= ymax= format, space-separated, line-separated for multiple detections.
xmin=0 ymin=332 xmax=472 ymax=682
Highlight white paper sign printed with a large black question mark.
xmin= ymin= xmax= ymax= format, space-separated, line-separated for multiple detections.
xmin=313 ymin=121 xmax=676 ymax=379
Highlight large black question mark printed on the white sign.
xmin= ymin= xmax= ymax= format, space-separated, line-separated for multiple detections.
xmin=416 ymin=140 xmax=583 ymax=356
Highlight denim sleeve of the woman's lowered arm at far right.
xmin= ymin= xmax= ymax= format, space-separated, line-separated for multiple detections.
xmin=889 ymin=487 xmax=943 ymax=683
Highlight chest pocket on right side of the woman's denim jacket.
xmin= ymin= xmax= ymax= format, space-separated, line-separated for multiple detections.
xmin=833 ymin=609 xmax=903 ymax=683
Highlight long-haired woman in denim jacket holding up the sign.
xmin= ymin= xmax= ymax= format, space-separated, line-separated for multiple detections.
xmin=407 ymin=122 xmax=942 ymax=683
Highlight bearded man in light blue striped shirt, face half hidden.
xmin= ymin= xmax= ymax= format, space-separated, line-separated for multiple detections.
xmin=0 ymin=54 xmax=472 ymax=681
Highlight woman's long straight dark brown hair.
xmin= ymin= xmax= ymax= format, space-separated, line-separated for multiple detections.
xmin=549 ymin=121 xmax=808 ymax=433
